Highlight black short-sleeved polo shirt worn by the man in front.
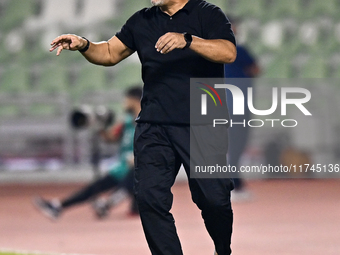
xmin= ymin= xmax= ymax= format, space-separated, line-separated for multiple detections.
xmin=116 ymin=0 xmax=235 ymax=124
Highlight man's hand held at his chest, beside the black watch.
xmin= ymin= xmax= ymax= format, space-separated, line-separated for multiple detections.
xmin=155 ymin=33 xmax=187 ymax=54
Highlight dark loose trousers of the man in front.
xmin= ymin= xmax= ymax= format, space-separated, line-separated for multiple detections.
xmin=134 ymin=123 xmax=233 ymax=255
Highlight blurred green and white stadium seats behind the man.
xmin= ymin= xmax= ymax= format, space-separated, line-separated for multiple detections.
xmin=0 ymin=0 xmax=340 ymax=166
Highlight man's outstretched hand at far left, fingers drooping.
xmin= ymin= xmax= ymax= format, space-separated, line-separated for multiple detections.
xmin=50 ymin=34 xmax=87 ymax=56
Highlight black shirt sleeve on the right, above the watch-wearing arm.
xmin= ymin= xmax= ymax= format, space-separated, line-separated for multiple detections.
xmin=204 ymin=6 xmax=236 ymax=45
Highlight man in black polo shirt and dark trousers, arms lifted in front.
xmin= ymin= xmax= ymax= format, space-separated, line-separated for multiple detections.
xmin=51 ymin=0 xmax=236 ymax=255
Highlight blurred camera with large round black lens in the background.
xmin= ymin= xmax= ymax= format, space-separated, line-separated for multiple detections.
xmin=70 ymin=105 xmax=115 ymax=131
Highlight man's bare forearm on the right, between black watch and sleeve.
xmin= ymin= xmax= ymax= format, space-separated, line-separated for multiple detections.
xmin=190 ymin=36 xmax=237 ymax=64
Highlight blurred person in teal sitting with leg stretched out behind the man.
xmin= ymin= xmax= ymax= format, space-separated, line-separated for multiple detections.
xmin=33 ymin=87 xmax=142 ymax=219
